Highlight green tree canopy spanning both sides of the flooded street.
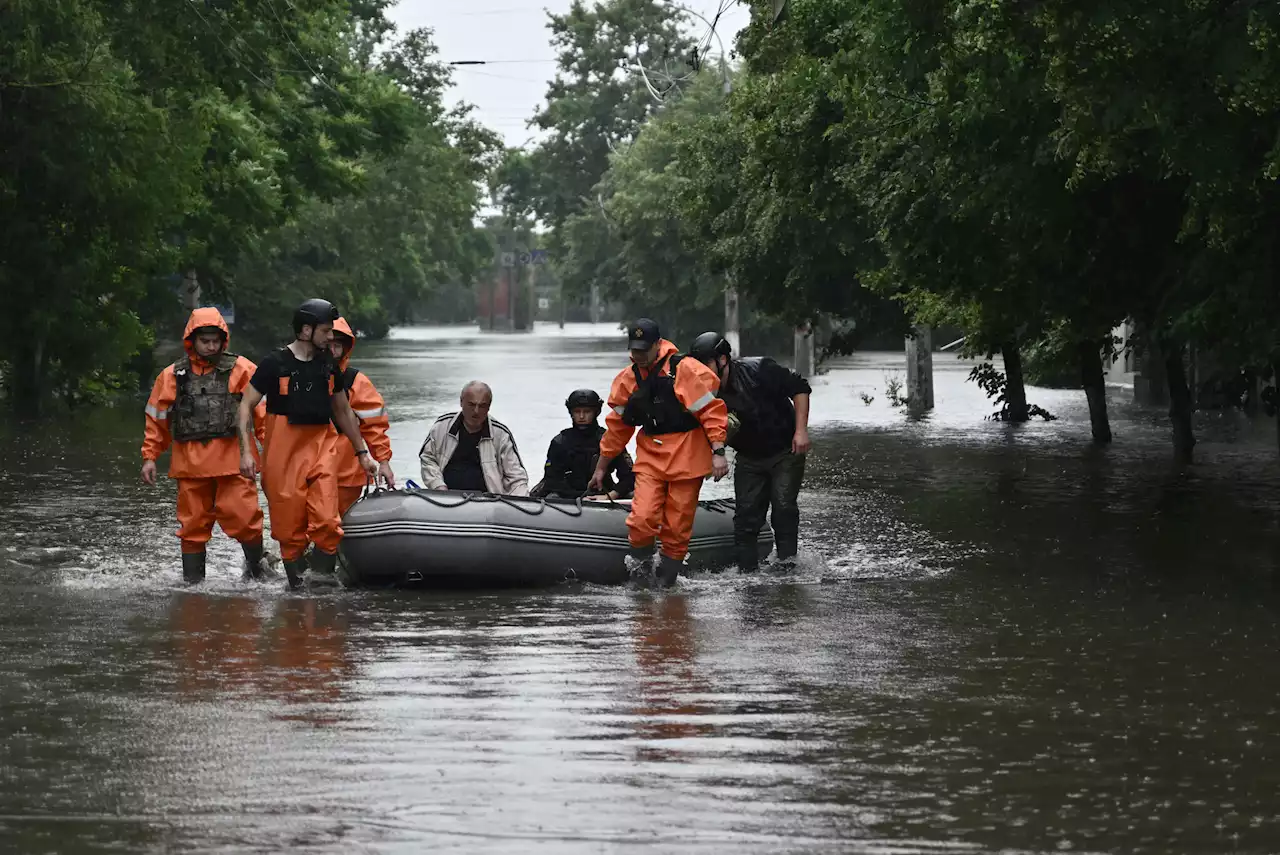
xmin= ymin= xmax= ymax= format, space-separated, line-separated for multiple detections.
xmin=10 ymin=0 xmax=1280 ymax=458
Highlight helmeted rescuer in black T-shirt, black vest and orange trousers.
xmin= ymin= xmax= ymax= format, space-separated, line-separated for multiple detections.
xmin=238 ymin=300 xmax=378 ymax=589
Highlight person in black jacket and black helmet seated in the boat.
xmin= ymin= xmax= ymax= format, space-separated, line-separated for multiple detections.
xmin=530 ymin=389 xmax=635 ymax=499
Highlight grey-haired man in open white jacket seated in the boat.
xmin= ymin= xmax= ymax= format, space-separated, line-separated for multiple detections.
xmin=419 ymin=380 xmax=529 ymax=495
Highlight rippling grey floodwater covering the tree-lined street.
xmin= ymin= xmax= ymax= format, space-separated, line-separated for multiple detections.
xmin=0 ymin=325 xmax=1280 ymax=854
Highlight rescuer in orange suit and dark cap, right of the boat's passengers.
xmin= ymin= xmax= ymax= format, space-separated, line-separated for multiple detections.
xmin=588 ymin=317 xmax=728 ymax=586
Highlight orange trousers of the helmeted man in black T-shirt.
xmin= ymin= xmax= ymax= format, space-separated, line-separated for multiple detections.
xmin=262 ymin=413 xmax=342 ymax=561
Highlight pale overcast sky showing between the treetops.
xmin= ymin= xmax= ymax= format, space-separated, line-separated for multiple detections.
xmin=390 ymin=0 xmax=750 ymax=146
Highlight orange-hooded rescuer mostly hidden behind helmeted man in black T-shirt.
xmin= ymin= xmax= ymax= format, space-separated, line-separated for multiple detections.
xmin=329 ymin=317 xmax=396 ymax=517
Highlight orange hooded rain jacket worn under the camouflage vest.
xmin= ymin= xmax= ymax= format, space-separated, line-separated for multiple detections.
xmin=142 ymin=307 xmax=266 ymax=479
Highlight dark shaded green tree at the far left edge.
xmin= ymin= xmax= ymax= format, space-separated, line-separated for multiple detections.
xmin=0 ymin=0 xmax=205 ymax=413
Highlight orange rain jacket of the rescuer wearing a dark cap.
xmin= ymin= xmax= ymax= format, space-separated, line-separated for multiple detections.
xmin=600 ymin=339 xmax=728 ymax=481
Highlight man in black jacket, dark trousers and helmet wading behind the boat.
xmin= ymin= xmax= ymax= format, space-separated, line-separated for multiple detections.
xmin=689 ymin=333 xmax=813 ymax=571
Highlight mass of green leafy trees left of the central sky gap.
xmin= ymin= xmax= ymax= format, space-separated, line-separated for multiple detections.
xmin=0 ymin=0 xmax=497 ymax=411
